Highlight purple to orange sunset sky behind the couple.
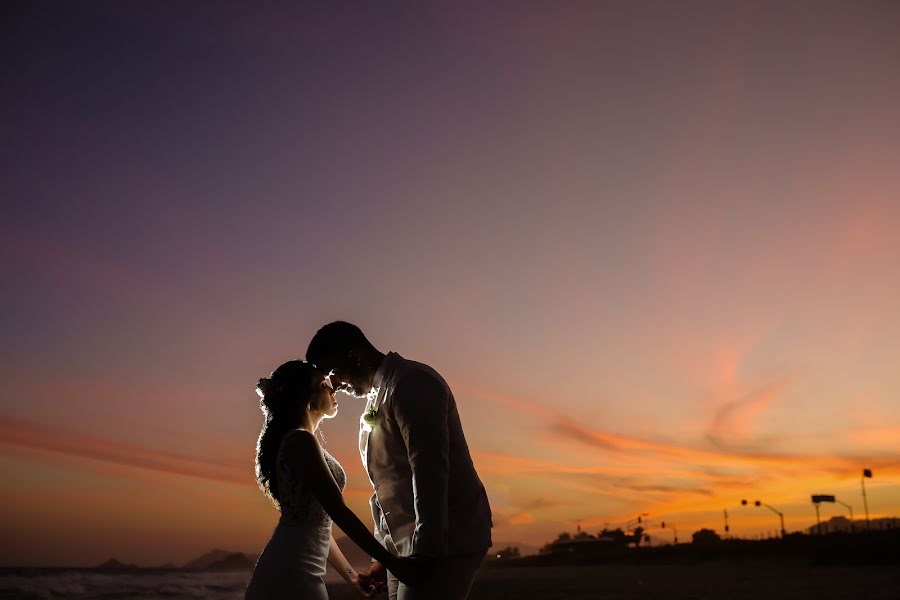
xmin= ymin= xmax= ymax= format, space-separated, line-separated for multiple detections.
xmin=0 ymin=0 xmax=900 ymax=565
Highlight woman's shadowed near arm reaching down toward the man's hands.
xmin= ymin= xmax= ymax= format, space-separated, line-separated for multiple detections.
xmin=283 ymin=430 xmax=400 ymax=575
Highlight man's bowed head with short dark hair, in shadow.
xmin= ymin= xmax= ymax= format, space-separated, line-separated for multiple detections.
xmin=306 ymin=321 xmax=384 ymax=398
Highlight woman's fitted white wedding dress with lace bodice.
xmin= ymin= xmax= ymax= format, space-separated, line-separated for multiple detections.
xmin=244 ymin=430 xmax=347 ymax=600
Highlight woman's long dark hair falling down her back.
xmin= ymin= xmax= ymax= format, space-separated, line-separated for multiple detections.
xmin=256 ymin=360 xmax=322 ymax=509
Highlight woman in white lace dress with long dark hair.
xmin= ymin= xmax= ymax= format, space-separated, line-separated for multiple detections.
xmin=244 ymin=360 xmax=419 ymax=600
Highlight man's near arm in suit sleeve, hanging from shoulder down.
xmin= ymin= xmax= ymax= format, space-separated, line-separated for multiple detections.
xmin=391 ymin=373 xmax=450 ymax=556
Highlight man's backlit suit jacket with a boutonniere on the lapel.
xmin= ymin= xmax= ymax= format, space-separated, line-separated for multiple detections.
xmin=359 ymin=352 xmax=493 ymax=557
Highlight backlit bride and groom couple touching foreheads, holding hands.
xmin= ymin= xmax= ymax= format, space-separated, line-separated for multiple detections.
xmin=245 ymin=321 xmax=492 ymax=600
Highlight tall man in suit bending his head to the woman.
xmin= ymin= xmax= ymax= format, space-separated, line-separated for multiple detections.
xmin=306 ymin=321 xmax=492 ymax=600
